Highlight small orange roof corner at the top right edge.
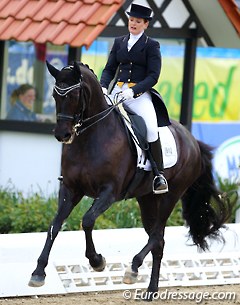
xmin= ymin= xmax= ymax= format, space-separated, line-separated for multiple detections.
xmin=218 ymin=0 xmax=240 ymax=36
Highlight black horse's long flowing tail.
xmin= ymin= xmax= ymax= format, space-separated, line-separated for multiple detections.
xmin=182 ymin=141 xmax=231 ymax=250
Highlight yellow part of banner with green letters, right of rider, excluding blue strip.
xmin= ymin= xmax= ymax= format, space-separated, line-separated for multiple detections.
xmin=156 ymin=57 xmax=240 ymax=122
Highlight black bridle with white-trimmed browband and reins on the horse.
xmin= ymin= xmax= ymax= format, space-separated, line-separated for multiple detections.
xmin=53 ymin=75 xmax=123 ymax=136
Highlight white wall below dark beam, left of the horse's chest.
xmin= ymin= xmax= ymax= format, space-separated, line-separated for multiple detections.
xmin=0 ymin=131 xmax=62 ymax=196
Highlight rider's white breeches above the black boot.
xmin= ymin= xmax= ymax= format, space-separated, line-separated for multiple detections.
xmin=111 ymin=84 xmax=158 ymax=142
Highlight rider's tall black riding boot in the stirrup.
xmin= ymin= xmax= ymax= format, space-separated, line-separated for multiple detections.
xmin=149 ymin=138 xmax=168 ymax=194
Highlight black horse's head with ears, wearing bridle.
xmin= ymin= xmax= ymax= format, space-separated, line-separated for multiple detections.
xmin=47 ymin=62 xmax=85 ymax=144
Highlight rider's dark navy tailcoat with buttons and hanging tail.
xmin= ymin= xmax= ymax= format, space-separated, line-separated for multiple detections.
xmin=100 ymin=33 xmax=171 ymax=126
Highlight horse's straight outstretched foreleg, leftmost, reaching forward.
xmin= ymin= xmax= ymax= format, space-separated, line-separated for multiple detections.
xmin=28 ymin=184 xmax=82 ymax=287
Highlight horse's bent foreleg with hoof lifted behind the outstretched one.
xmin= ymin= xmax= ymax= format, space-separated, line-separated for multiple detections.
xmin=82 ymin=187 xmax=115 ymax=271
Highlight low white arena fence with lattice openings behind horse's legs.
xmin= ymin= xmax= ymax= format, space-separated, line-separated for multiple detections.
xmin=0 ymin=224 xmax=240 ymax=297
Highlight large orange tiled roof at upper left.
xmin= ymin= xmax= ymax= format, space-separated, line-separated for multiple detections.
xmin=0 ymin=0 xmax=125 ymax=47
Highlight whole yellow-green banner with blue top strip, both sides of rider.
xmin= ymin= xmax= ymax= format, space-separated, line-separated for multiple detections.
xmin=82 ymin=47 xmax=240 ymax=122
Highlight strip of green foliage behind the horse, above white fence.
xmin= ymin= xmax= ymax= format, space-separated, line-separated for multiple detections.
xmin=0 ymin=179 xmax=239 ymax=234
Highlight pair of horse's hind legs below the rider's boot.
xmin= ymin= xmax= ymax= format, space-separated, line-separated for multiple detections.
xmin=124 ymin=193 xmax=177 ymax=300
